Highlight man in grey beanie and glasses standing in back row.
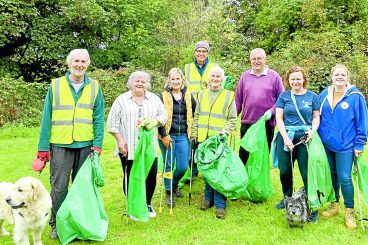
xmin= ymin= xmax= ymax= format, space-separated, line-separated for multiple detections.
xmin=184 ymin=41 xmax=215 ymax=100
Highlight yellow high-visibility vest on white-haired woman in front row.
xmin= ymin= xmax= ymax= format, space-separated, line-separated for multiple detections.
xmin=197 ymin=89 xmax=234 ymax=142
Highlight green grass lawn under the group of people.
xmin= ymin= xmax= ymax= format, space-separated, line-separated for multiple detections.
xmin=0 ymin=127 xmax=368 ymax=245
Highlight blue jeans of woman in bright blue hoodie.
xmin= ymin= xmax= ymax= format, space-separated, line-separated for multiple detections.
xmin=325 ymin=148 xmax=354 ymax=208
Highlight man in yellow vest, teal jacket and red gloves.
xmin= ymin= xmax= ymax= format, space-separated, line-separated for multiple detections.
xmin=34 ymin=49 xmax=104 ymax=239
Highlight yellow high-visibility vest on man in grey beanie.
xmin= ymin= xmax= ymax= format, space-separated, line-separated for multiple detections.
xmin=184 ymin=62 xmax=216 ymax=100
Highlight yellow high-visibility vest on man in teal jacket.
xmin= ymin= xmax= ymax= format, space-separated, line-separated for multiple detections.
xmin=50 ymin=76 xmax=99 ymax=144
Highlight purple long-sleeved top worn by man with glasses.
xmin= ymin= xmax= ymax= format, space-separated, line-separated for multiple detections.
xmin=235 ymin=67 xmax=285 ymax=126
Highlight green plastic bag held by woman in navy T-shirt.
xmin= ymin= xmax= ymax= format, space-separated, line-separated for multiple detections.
xmin=307 ymin=130 xmax=335 ymax=210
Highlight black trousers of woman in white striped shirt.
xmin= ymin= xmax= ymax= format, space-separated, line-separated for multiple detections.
xmin=119 ymin=153 xmax=157 ymax=205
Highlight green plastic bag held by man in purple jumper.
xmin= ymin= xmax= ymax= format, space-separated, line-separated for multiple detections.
xmin=240 ymin=117 xmax=273 ymax=202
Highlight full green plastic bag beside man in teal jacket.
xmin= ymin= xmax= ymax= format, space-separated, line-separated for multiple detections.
xmin=56 ymin=152 xmax=108 ymax=244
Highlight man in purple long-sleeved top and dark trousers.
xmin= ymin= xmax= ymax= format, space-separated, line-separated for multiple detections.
xmin=235 ymin=48 xmax=285 ymax=165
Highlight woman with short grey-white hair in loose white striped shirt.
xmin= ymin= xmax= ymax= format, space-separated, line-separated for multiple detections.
xmin=107 ymin=71 xmax=167 ymax=219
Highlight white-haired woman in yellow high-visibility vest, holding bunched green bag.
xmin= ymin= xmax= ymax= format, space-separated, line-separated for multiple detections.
xmin=191 ymin=66 xmax=236 ymax=219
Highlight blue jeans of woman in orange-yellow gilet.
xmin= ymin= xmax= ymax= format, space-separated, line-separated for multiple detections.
xmin=158 ymin=134 xmax=190 ymax=190
